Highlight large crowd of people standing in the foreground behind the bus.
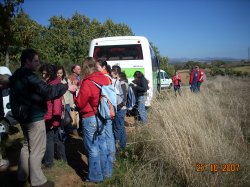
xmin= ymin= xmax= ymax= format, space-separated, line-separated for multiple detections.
xmin=1 ymin=49 xmax=148 ymax=186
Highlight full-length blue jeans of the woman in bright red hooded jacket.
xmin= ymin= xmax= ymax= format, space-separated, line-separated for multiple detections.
xmin=82 ymin=116 xmax=112 ymax=182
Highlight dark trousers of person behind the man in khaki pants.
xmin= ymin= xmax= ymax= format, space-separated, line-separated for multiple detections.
xmin=43 ymin=128 xmax=67 ymax=167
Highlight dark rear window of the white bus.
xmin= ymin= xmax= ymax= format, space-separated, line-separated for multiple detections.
xmin=93 ymin=44 xmax=143 ymax=61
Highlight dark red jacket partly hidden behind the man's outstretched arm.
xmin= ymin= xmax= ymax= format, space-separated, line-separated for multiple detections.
xmin=44 ymin=79 xmax=62 ymax=127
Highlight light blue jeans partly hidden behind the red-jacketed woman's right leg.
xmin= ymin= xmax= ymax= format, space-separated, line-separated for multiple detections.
xmin=103 ymin=120 xmax=116 ymax=163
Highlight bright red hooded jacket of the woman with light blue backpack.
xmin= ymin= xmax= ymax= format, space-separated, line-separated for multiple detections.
xmin=74 ymin=72 xmax=110 ymax=118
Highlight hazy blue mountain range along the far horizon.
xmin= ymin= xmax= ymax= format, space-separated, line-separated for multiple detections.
xmin=169 ymin=57 xmax=247 ymax=64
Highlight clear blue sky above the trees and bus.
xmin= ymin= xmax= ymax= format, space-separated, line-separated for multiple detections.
xmin=22 ymin=0 xmax=250 ymax=59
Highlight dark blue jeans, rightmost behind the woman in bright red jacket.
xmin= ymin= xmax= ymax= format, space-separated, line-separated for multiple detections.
xmin=114 ymin=109 xmax=127 ymax=149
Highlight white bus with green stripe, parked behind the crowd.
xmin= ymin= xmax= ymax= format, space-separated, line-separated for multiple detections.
xmin=89 ymin=36 xmax=161 ymax=106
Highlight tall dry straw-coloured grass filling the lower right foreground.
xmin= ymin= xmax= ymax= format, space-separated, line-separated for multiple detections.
xmin=126 ymin=77 xmax=250 ymax=187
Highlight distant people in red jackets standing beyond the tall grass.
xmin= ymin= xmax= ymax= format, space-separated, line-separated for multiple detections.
xmin=172 ymin=66 xmax=204 ymax=96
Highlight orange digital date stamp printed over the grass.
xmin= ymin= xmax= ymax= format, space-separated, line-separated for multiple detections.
xmin=195 ymin=163 xmax=240 ymax=172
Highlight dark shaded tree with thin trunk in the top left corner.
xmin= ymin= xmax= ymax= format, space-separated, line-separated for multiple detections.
xmin=0 ymin=0 xmax=23 ymax=67
